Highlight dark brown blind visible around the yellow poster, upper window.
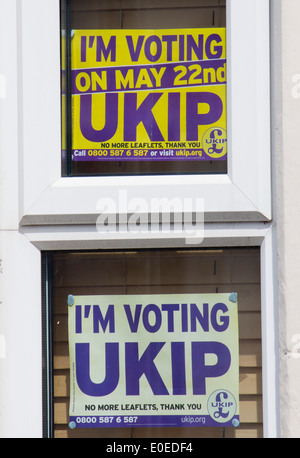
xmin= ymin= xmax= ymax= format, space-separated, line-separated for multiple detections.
xmin=61 ymin=0 xmax=227 ymax=176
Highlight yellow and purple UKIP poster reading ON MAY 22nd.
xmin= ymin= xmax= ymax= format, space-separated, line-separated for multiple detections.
xmin=71 ymin=28 xmax=227 ymax=161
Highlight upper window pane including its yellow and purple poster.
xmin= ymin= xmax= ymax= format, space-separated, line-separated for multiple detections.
xmin=62 ymin=0 xmax=227 ymax=176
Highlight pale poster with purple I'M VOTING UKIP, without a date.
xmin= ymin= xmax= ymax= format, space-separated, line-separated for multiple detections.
xmin=68 ymin=293 xmax=239 ymax=428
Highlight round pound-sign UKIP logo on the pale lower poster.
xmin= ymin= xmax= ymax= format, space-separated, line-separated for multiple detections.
xmin=207 ymin=390 xmax=236 ymax=423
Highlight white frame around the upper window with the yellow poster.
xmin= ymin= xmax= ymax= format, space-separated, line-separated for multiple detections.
xmin=19 ymin=0 xmax=271 ymax=225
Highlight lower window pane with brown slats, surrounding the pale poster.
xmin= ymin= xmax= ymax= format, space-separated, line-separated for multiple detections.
xmin=51 ymin=248 xmax=262 ymax=438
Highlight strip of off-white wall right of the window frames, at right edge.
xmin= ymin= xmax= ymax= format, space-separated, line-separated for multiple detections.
xmin=271 ymin=0 xmax=300 ymax=438
